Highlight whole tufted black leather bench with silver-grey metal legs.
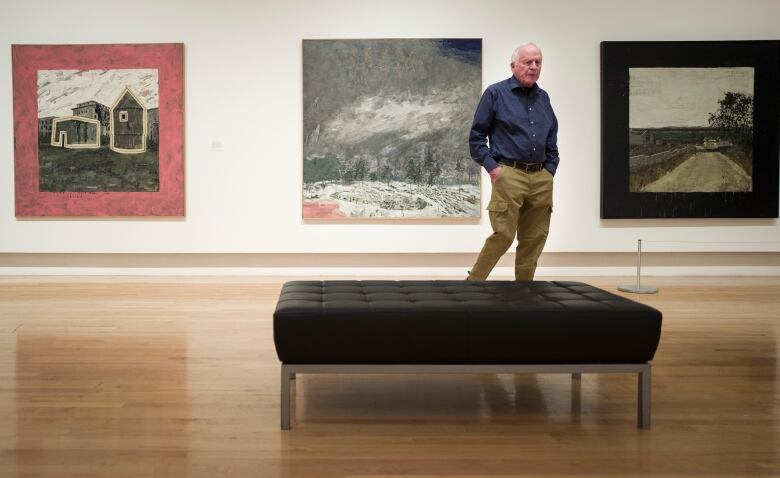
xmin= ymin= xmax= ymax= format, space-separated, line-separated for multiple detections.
xmin=274 ymin=280 xmax=662 ymax=430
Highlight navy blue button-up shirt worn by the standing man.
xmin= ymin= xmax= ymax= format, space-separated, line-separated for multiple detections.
xmin=469 ymin=76 xmax=560 ymax=174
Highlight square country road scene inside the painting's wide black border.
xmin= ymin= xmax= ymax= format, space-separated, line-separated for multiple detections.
xmin=629 ymin=67 xmax=754 ymax=193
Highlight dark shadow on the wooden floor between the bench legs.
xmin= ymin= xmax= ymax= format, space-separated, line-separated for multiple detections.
xmin=292 ymin=374 xmax=588 ymax=428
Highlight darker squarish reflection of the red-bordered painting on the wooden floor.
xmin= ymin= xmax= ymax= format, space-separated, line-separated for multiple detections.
xmin=15 ymin=330 xmax=187 ymax=476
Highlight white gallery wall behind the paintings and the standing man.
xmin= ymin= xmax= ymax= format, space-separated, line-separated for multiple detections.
xmin=0 ymin=0 xmax=780 ymax=253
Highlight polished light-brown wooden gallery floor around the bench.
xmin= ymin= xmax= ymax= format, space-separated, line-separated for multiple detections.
xmin=0 ymin=277 xmax=780 ymax=478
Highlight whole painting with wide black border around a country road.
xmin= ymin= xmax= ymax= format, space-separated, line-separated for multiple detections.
xmin=601 ymin=40 xmax=780 ymax=219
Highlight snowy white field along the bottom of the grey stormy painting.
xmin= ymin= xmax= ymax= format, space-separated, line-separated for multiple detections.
xmin=303 ymin=181 xmax=480 ymax=218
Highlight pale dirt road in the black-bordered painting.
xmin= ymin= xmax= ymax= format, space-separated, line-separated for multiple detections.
xmin=642 ymin=151 xmax=752 ymax=193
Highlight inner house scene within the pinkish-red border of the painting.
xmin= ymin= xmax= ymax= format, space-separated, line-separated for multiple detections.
xmin=32 ymin=68 xmax=159 ymax=192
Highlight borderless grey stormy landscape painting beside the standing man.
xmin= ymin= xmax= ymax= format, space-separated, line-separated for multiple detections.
xmin=303 ymin=39 xmax=482 ymax=219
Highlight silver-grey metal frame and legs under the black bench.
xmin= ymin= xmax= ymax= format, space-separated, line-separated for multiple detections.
xmin=281 ymin=362 xmax=652 ymax=430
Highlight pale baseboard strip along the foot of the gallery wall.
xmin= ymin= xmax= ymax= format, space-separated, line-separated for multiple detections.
xmin=0 ymin=252 xmax=780 ymax=278
